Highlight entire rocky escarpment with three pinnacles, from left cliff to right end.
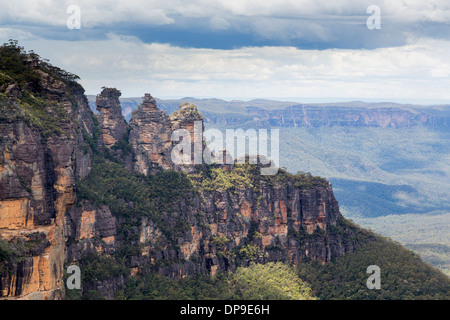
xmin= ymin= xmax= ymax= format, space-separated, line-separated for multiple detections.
xmin=0 ymin=45 xmax=361 ymax=299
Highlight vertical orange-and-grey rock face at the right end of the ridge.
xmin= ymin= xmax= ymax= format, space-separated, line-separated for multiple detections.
xmin=134 ymin=179 xmax=356 ymax=278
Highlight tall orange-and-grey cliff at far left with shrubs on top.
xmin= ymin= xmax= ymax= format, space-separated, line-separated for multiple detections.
xmin=0 ymin=46 xmax=94 ymax=299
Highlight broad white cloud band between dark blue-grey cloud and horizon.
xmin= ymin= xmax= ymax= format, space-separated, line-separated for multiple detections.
xmin=6 ymin=29 xmax=450 ymax=100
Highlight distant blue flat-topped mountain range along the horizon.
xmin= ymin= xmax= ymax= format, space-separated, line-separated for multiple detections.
xmin=88 ymin=95 xmax=450 ymax=128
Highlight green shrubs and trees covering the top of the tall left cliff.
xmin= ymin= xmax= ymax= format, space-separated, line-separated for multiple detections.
xmin=0 ymin=40 xmax=83 ymax=137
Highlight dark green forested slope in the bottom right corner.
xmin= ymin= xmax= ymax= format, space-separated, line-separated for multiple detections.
xmin=298 ymin=236 xmax=450 ymax=300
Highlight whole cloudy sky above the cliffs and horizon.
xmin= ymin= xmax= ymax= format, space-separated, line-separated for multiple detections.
xmin=0 ymin=0 xmax=450 ymax=103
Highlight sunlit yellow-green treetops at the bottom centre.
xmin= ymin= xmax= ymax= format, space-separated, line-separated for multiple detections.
xmin=230 ymin=262 xmax=313 ymax=300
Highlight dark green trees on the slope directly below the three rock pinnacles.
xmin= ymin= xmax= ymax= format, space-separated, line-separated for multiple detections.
xmin=78 ymin=157 xmax=192 ymax=244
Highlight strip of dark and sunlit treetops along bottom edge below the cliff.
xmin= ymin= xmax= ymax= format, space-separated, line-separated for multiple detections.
xmin=115 ymin=263 xmax=314 ymax=300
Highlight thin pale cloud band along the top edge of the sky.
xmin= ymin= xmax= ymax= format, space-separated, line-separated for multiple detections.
xmin=0 ymin=0 xmax=450 ymax=31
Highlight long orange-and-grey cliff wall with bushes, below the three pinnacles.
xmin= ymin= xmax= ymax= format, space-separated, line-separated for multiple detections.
xmin=67 ymin=165 xmax=358 ymax=298
